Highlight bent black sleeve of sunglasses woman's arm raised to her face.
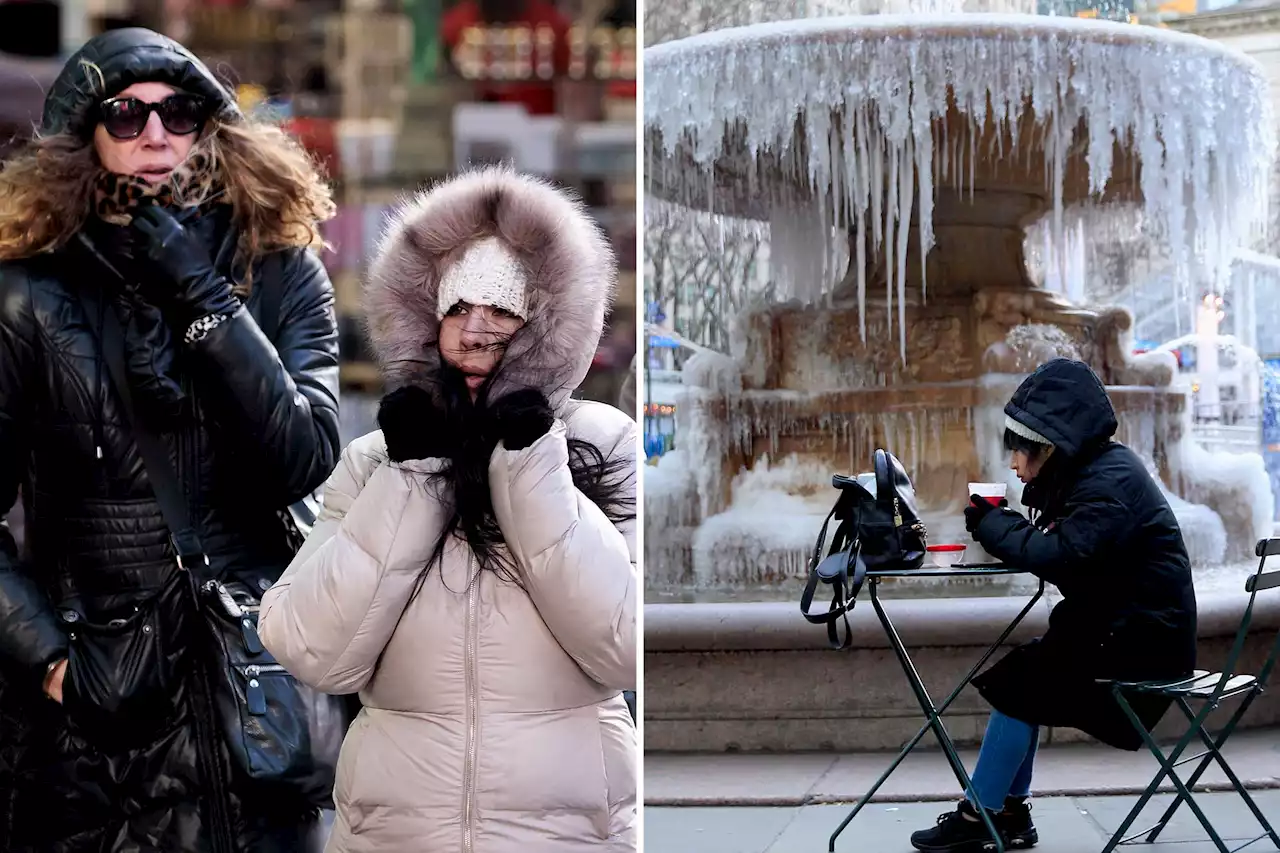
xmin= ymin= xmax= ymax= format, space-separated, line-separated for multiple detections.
xmin=191 ymin=250 xmax=342 ymax=506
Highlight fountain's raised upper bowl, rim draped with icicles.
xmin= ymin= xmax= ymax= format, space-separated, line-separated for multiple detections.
xmin=645 ymin=14 xmax=1265 ymax=219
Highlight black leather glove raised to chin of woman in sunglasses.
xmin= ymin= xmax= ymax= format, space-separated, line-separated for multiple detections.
xmin=132 ymin=206 xmax=239 ymax=330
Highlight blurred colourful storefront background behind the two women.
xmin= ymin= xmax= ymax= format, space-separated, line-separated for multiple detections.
xmin=0 ymin=0 xmax=636 ymax=432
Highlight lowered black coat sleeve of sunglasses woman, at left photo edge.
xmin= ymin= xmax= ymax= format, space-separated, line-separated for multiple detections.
xmin=0 ymin=266 xmax=67 ymax=689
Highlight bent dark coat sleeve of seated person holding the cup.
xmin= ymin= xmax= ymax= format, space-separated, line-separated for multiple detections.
xmin=974 ymin=479 xmax=1134 ymax=584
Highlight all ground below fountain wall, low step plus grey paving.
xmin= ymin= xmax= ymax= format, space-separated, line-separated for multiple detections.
xmin=644 ymin=729 xmax=1280 ymax=853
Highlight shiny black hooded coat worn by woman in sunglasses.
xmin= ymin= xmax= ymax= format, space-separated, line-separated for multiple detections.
xmin=0 ymin=29 xmax=339 ymax=853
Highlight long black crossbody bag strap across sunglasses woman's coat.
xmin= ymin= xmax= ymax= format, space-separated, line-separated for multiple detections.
xmin=82 ymin=280 xmax=209 ymax=570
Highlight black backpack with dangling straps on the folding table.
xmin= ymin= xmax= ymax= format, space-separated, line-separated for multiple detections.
xmin=800 ymin=450 xmax=928 ymax=649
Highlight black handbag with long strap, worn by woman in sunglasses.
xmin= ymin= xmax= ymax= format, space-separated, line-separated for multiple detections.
xmin=90 ymin=277 xmax=348 ymax=808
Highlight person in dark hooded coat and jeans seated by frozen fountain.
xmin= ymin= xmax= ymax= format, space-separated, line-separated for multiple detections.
xmin=911 ymin=359 xmax=1196 ymax=853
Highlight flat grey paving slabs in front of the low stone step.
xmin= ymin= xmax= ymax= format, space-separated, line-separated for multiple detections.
xmin=644 ymin=790 xmax=1280 ymax=853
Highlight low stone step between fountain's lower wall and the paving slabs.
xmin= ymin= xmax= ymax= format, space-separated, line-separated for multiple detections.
xmin=644 ymin=729 xmax=1280 ymax=804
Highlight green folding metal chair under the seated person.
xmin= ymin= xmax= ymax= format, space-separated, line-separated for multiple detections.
xmin=1102 ymin=539 xmax=1280 ymax=853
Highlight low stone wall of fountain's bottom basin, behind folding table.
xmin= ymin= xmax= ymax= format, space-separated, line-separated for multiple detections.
xmin=644 ymin=584 xmax=1280 ymax=752
